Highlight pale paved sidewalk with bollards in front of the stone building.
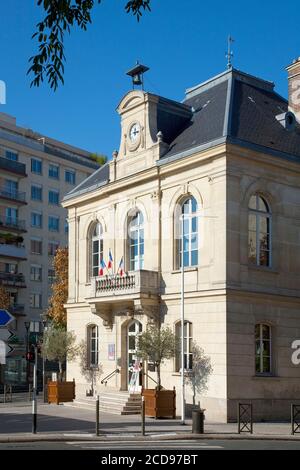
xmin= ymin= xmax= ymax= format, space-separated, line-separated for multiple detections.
xmin=0 ymin=402 xmax=300 ymax=443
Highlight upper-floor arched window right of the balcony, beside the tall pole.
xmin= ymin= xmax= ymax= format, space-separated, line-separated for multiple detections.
xmin=176 ymin=197 xmax=198 ymax=268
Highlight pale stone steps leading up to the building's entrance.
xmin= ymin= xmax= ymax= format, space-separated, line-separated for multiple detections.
xmin=65 ymin=391 xmax=142 ymax=415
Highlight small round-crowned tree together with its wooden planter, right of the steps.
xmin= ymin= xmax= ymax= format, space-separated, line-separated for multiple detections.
xmin=137 ymin=326 xmax=176 ymax=419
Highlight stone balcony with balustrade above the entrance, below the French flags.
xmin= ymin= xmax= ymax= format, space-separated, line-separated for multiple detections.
xmin=86 ymin=269 xmax=159 ymax=326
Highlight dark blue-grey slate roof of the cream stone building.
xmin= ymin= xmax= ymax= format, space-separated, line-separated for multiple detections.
xmin=65 ymin=69 xmax=300 ymax=199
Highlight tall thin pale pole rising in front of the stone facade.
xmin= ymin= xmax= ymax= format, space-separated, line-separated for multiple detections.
xmin=179 ymin=212 xmax=200 ymax=424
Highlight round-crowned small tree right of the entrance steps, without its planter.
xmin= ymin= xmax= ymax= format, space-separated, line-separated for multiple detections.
xmin=137 ymin=326 xmax=177 ymax=390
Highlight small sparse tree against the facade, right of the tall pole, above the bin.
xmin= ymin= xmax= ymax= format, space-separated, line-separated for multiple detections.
xmin=185 ymin=342 xmax=213 ymax=412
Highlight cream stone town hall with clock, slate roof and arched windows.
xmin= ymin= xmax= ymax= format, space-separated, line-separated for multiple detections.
xmin=63 ymin=60 xmax=300 ymax=422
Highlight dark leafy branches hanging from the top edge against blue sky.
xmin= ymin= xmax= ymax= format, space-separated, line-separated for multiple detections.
xmin=28 ymin=0 xmax=151 ymax=90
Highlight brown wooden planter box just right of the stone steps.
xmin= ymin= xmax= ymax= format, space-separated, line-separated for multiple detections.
xmin=142 ymin=388 xmax=176 ymax=419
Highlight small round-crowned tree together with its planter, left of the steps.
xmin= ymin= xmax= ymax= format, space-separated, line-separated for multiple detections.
xmin=42 ymin=325 xmax=78 ymax=405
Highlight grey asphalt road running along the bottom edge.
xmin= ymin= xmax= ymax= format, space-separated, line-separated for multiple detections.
xmin=0 ymin=440 xmax=300 ymax=455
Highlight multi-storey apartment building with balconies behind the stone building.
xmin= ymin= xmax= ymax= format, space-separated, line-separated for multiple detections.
xmin=0 ymin=113 xmax=99 ymax=384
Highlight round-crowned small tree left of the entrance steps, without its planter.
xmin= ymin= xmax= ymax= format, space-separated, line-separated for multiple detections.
xmin=42 ymin=324 xmax=79 ymax=380
